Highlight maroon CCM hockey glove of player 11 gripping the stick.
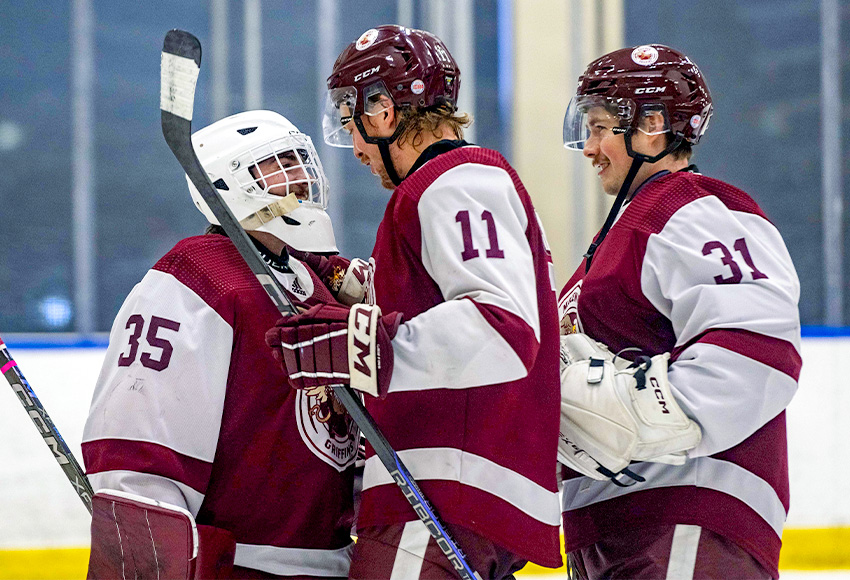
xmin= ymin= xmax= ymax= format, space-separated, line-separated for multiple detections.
xmin=266 ymin=304 xmax=402 ymax=398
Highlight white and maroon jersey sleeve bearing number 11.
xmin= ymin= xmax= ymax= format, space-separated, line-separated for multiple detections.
xmin=389 ymin=163 xmax=540 ymax=392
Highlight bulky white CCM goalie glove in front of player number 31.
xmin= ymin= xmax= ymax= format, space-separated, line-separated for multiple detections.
xmin=558 ymin=334 xmax=702 ymax=485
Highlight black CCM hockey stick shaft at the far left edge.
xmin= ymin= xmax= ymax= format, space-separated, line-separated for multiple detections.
xmin=0 ymin=338 xmax=94 ymax=513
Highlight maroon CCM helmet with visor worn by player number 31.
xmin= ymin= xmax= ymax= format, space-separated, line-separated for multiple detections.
xmin=564 ymin=44 xmax=712 ymax=149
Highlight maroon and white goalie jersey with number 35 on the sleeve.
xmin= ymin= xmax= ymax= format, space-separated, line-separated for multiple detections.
xmin=82 ymin=235 xmax=358 ymax=576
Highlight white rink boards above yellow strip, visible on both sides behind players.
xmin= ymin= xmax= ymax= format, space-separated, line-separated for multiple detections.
xmin=0 ymin=337 xmax=850 ymax=549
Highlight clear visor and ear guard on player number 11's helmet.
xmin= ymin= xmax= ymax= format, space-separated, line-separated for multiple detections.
xmin=322 ymin=81 xmax=393 ymax=147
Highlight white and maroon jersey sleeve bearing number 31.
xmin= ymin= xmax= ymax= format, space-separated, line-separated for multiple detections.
xmin=641 ymin=196 xmax=800 ymax=456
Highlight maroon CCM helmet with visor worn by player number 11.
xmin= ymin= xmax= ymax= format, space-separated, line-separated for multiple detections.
xmin=322 ymin=24 xmax=460 ymax=147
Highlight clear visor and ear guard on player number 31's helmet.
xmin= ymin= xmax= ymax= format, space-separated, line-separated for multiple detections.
xmin=564 ymin=95 xmax=670 ymax=151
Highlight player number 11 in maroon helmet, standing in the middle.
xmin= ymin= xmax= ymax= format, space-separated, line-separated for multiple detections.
xmin=267 ymin=25 xmax=561 ymax=579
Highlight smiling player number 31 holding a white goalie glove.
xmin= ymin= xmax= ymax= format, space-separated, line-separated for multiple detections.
xmin=559 ymin=45 xmax=801 ymax=578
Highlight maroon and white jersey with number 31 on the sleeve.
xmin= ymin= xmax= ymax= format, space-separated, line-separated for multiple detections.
xmin=559 ymin=172 xmax=801 ymax=575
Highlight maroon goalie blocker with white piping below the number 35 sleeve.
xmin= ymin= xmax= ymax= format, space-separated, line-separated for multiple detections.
xmin=87 ymin=489 xmax=236 ymax=580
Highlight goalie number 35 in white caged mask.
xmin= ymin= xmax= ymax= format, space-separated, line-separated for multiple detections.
xmin=82 ymin=111 xmax=358 ymax=578
